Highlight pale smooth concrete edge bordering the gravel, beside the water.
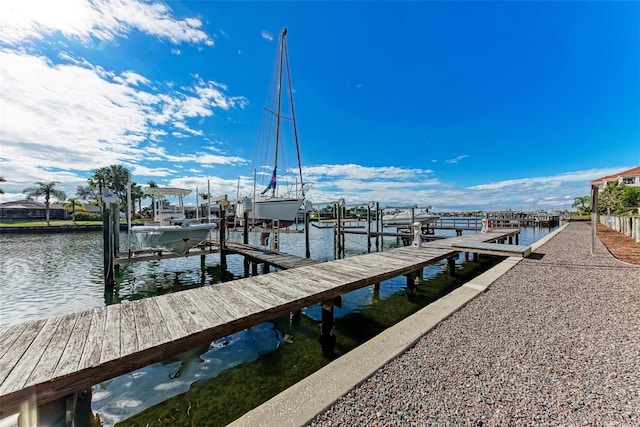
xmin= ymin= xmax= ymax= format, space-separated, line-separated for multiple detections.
xmin=229 ymin=224 xmax=567 ymax=427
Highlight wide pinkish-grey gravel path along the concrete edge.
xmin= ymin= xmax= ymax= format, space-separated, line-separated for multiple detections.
xmin=310 ymin=223 xmax=640 ymax=426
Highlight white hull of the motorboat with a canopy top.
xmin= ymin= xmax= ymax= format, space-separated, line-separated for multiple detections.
xmin=131 ymin=224 xmax=216 ymax=253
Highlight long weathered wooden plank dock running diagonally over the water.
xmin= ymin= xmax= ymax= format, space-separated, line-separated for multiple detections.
xmin=0 ymin=229 xmax=519 ymax=417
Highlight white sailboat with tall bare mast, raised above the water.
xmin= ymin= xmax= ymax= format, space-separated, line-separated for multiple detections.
xmin=236 ymin=28 xmax=312 ymax=227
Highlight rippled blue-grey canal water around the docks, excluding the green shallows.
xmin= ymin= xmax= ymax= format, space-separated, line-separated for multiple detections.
xmin=0 ymin=222 xmax=549 ymax=426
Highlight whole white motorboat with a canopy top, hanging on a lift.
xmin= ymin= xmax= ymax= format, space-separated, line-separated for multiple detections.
xmin=131 ymin=187 xmax=216 ymax=254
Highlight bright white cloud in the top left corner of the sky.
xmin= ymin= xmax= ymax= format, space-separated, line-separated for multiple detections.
xmin=0 ymin=0 xmax=213 ymax=46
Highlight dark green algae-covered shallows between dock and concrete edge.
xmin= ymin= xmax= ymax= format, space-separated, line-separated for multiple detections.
xmin=117 ymin=257 xmax=502 ymax=427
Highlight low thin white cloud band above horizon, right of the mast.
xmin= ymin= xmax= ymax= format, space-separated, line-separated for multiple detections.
xmin=288 ymin=164 xmax=629 ymax=211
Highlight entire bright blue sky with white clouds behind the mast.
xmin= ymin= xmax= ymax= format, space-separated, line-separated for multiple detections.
xmin=0 ymin=0 xmax=640 ymax=210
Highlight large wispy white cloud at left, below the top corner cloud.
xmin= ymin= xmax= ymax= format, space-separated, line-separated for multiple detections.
xmin=0 ymin=49 xmax=246 ymax=189
